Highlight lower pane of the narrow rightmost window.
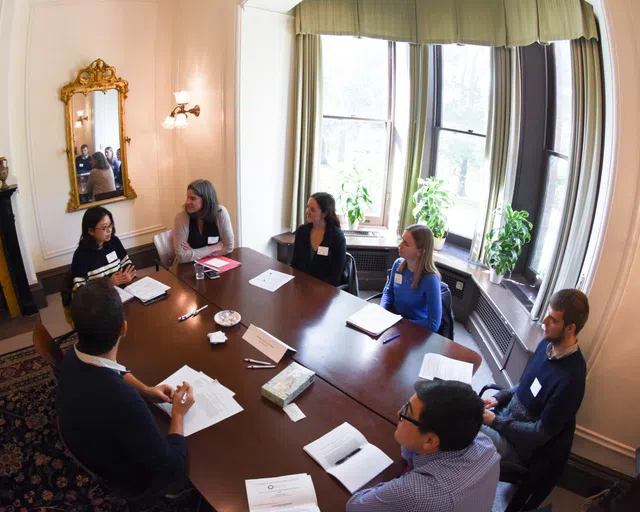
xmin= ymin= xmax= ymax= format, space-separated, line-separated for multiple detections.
xmin=531 ymin=155 xmax=569 ymax=278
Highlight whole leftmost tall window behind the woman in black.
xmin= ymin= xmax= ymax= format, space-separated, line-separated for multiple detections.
xmin=318 ymin=36 xmax=395 ymax=225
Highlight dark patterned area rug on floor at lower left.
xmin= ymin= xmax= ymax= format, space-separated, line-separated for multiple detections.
xmin=0 ymin=336 xmax=211 ymax=512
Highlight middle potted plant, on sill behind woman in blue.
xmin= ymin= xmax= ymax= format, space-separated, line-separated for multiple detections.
xmin=413 ymin=177 xmax=453 ymax=251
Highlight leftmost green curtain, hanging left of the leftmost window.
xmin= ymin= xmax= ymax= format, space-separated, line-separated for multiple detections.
xmin=290 ymin=34 xmax=322 ymax=231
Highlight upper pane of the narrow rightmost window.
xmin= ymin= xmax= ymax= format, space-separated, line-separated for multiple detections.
xmin=551 ymin=41 xmax=573 ymax=156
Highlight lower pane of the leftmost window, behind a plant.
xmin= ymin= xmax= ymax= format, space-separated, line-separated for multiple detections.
xmin=318 ymin=118 xmax=387 ymax=217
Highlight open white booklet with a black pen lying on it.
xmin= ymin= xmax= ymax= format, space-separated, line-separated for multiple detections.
xmin=304 ymin=422 xmax=393 ymax=494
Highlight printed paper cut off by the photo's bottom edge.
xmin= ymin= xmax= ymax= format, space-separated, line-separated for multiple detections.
xmin=244 ymin=473 xmax=320 ymax=512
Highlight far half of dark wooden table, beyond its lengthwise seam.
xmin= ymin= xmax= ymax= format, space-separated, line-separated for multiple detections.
xmin=172 ymin=248 xmax=482 ymax=422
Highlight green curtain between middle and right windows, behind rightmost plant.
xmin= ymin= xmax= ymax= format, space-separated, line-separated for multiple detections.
xmin=469 ymin=48 xmax=516 ymax=261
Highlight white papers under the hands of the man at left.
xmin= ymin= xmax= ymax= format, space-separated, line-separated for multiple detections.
xmin=156 ymin=365 xmax=244 ymax=436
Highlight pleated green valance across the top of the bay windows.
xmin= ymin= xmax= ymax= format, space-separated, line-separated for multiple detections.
xmin=296 ymin=0 xmax=598 ymax=47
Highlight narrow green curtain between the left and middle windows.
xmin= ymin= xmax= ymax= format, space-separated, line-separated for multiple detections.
xmin=397 ymin=45 xmax=430 ymax=233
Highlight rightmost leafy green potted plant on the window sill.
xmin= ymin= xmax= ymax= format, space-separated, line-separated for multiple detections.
xmin=485 ymin=205 xmax=533 ymax=284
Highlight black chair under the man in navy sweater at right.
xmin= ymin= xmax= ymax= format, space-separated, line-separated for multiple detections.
xmin=480 ymin=384 xmax=576 ymax=512
